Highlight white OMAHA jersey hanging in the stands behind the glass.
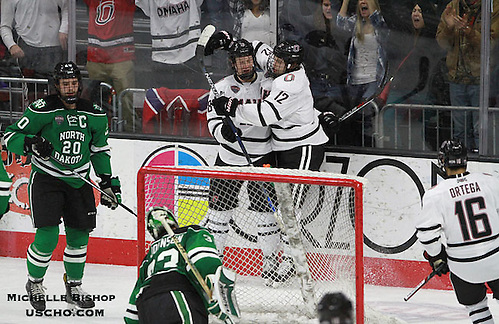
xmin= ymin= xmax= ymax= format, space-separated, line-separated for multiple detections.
xmin=135 ymin=0 xmax=203 ymax=64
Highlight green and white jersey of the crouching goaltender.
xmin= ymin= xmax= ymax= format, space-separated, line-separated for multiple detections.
xmin=125 ymin=225 xmax=222 ymax=324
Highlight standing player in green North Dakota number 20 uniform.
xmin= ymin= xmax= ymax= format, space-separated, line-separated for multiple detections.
xmin=4 ymin=62 xmax=121 ymax=310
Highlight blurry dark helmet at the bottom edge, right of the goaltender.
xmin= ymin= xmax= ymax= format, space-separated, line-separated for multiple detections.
xmin=317 ymin=292 xmax=353 ymax=324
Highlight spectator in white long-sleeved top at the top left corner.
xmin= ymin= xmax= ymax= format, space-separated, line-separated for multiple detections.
xmin=0 ymin=0 xmax=68 ymax=78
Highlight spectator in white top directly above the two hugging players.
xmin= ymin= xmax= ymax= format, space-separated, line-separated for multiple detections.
xmin=229 ymin=0 xmax=275 ymax=46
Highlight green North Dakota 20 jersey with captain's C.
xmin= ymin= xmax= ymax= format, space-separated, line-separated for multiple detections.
xmin=4 ymin=95 xmax=112 ymax=188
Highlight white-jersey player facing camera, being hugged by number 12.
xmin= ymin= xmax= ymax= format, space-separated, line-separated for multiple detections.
xmin=202 ymin=39 xmax=279 ymax=279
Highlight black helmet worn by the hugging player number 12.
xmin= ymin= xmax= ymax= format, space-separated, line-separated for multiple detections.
xmin=268 ymin=40 xmax=304 ymax=77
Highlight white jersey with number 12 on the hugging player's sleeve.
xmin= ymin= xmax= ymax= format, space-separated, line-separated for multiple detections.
xmin=236 ymin=41 xmax=328 ymax=151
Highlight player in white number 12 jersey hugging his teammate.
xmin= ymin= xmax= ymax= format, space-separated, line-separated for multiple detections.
xmin=214 ymin=41 xmax=328 ymax=171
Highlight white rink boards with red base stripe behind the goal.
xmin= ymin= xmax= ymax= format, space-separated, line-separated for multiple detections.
xmin=0 ymin=139 xmax=498 ymax=288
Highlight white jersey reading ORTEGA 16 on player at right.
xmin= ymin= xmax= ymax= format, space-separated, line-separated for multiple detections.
xmin=416 ymin=173 xmax=499 ymax=283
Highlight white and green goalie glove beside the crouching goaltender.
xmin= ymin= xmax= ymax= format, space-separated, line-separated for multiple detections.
xmin=206 ymin=266 xmax=240 ymax=323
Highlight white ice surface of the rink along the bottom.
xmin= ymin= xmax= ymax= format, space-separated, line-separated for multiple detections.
xmin=0 ymin=258 xmax=499 ymax=324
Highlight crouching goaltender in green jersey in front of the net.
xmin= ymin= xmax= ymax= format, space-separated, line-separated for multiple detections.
xmin=125 ymin=207 xmax=239 ymax=324
